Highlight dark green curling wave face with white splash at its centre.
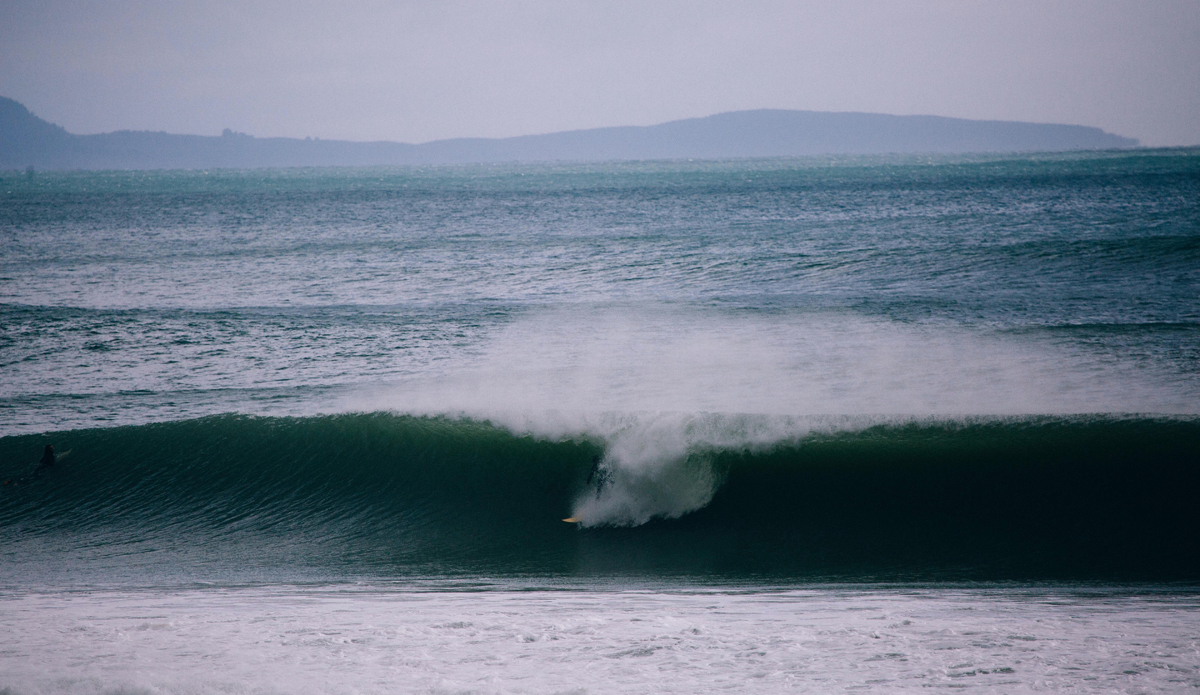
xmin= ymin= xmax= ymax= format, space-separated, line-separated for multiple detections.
xmin=0 ymin=413 xmax=1200 ymax=583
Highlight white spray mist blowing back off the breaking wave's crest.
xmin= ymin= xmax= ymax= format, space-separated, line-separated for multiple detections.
xmin=349 ymin=305 xmax=1196 ymax=417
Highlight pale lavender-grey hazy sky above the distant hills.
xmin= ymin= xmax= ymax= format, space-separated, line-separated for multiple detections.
xmin=0 ymin=0 xmax=1200 ymax=146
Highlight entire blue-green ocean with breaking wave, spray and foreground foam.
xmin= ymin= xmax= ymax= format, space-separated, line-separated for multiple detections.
xmin=0 ymin=149 xmax=1200 ymax=695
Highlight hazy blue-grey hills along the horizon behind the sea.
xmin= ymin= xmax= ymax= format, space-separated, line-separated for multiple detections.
xmin=0 ymin=97 xmax=1138 ymax=169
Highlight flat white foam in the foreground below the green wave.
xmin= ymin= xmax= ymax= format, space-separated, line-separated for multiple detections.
xmin=0 ymin=586 xmax=1200 ymax=695
